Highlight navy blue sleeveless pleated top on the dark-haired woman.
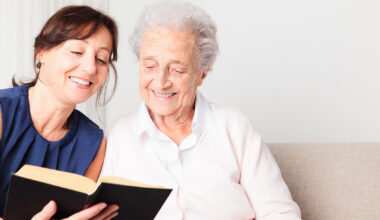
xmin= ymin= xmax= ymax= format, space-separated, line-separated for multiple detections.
xmin=0 ymin=85 xmax=103 ymax=216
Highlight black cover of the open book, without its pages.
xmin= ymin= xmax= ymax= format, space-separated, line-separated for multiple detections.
xmin=4 ymin=175 xmax=171 ymax=220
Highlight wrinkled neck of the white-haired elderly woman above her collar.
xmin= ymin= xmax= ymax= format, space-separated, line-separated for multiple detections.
xmin=149 ymin=107 xmax=195 ymax=146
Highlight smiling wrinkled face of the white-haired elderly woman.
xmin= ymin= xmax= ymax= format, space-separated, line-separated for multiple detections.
xmin=139 ymin=28 xmax=206 ymax=116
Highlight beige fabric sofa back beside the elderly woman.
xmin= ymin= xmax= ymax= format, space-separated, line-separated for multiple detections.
xmin=268 ymin=143 xmax=380 ymax=220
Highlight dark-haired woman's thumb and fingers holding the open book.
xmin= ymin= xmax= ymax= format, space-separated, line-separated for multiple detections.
xmin=30 ymin=201 xmax=119 ymax=220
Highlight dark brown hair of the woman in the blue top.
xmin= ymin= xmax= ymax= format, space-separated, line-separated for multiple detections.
xmin=12 ymin=6 xmax=118 ymax=104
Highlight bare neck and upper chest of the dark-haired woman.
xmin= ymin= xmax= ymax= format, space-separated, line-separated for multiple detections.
xmin=29 ymin=82 xmax=75 ymax=141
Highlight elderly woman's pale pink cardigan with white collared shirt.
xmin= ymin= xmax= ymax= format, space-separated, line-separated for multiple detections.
xmin=101 ymin=93 xmax=301 ymax=220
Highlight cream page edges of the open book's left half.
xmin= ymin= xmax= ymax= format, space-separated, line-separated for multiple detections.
xmin=15 ymin=164 xmax=97 ymax=194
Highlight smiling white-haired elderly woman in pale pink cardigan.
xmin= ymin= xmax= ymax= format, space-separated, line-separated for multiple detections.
xmin=101 ymin=1 xmax=300 ymax=220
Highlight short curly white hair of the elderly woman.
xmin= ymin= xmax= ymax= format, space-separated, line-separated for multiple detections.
xmin=129 ymin=0 xmax=219 ymax=71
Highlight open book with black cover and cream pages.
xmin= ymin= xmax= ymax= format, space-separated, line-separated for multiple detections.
xmin=4 ymin=165 xmax=171 ymax=220
